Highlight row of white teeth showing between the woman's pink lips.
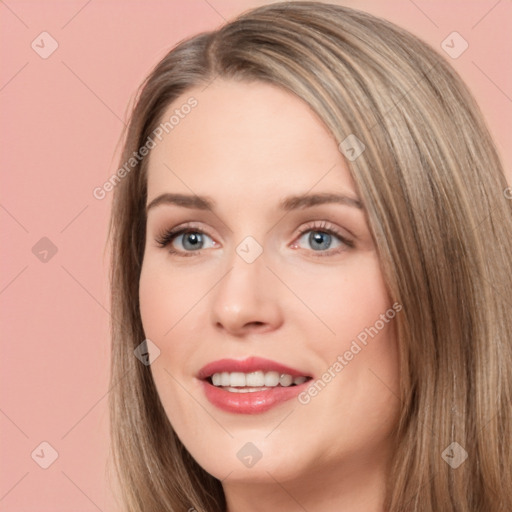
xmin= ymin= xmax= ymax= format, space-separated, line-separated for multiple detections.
xmin=211 ymin=371 xmax=307 ymax=393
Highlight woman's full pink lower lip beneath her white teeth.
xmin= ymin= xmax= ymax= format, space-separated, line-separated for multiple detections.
xmin=202 ymin=381 xmax=309 ymax=414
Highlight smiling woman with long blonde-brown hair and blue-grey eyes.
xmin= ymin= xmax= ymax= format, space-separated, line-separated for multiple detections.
xmin=106 ymin=2 xmax=512 ymax=512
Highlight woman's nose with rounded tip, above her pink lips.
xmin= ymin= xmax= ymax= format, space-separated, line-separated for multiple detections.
xmin=211 ymin=246 xmax=283 ymax=337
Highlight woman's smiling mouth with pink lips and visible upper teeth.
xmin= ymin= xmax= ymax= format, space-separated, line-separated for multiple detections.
xmin=197 ymin=357 xmax=312 ymax=414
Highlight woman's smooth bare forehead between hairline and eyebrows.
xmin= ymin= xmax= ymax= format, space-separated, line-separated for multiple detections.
xmin=144 ymin=79 xmax=354 ymax=200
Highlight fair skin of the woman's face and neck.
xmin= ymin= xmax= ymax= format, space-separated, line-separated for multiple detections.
xmin=140 ymin=79 xmax=400 ymax=512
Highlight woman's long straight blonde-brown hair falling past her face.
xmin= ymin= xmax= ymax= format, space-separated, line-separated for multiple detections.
xmin=109 ymin=2 xmax=512 ymax=512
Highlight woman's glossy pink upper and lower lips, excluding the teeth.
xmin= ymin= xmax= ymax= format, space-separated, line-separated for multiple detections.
xmin=198 ymin=357 xmax=309 ymax=414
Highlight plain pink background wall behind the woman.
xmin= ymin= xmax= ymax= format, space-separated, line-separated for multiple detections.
xmin=0 ymin=0 xmax=512 ymax=512
